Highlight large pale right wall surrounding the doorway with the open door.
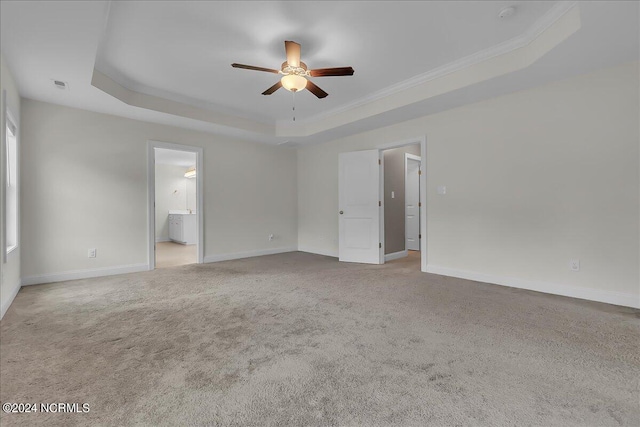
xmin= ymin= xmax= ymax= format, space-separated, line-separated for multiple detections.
xmin=298 ymin=63 xmax=640 ymax=306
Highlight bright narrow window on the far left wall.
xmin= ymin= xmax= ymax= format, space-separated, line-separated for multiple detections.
xmin=5 ymin=115 xmax=19 ymax=253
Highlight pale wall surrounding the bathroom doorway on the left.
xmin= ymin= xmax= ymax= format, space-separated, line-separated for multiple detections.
xmin=22 ymin=99 xmax=297 ymax=284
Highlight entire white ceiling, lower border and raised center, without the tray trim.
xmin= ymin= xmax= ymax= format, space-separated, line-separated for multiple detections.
xmin=0 ymin=1 xmax=640 ymax=143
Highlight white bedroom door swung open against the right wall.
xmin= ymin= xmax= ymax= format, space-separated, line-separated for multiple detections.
xmin=338 ymin=150 xmax=383 ymax=264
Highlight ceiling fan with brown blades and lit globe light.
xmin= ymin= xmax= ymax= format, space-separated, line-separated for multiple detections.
xmin=231 ymin=41 xmax=353 ymax=98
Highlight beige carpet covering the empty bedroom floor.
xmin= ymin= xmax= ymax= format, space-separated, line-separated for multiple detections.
xmin=0 ymin=253 xmax=640 ymax=426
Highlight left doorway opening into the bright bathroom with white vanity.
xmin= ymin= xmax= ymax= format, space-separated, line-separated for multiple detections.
xmin=149 ymin=141 xmax=203 ymax=270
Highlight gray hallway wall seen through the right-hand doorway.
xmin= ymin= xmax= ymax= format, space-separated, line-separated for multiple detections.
xmin=383 ymin=145 xmax=420 ymax=254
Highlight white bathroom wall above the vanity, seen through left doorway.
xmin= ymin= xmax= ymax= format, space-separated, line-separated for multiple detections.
xmin=156 ymin=163 xmax=196 ymax=242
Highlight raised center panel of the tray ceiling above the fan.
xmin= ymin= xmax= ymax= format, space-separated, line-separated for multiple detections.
xmin=97 ymin=1 xmax=553 ymax=122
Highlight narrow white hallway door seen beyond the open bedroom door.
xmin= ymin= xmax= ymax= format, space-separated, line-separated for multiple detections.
xmin=404 ymin=154 xmax=420 ymax=251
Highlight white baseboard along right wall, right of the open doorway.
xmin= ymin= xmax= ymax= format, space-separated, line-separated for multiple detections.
xmin=427 ymin=265 xmax=640 ymax=308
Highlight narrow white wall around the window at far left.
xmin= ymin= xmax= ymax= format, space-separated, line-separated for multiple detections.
xmin=0 ymin=53 xmax=22 ymax=319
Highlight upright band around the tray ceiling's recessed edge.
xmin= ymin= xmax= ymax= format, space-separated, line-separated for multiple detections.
xmin=91 ymin=1 xmax=581 ymax=142
